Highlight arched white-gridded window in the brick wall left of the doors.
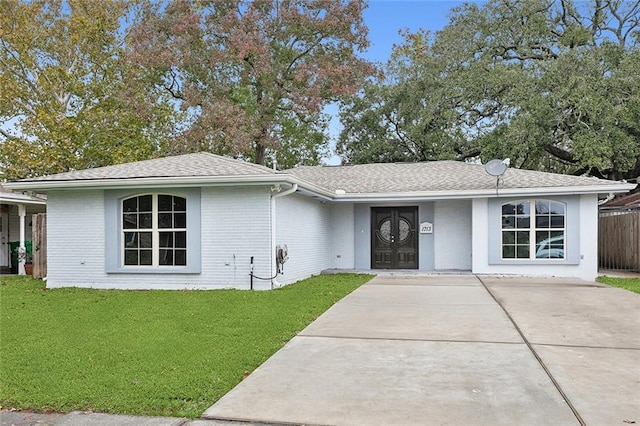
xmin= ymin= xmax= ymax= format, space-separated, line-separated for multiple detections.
xmin=121 ymin=194 xmax=187 ymax=267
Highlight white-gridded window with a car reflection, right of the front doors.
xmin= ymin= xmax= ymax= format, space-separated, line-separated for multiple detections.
xmin=502 ymin=200 xmax=566 ymax=259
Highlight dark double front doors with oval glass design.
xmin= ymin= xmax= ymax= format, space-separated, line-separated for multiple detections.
xmin=371 ymin=207 xmax=418 ymax=269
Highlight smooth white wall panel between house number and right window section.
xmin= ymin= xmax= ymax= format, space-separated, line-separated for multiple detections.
xmin=433 ymin=200 xmax=471 ymax=270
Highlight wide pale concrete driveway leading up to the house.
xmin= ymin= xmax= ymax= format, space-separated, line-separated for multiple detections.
xmin=203 ymin=275 xmax=640 ymax=425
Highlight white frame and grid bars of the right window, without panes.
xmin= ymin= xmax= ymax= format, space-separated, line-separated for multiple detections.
xmin=500 ymin=198 xmax=567 ymax=262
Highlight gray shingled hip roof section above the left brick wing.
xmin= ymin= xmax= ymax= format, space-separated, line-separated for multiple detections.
xmin=23 ymin=152 xmax=275 ymax=182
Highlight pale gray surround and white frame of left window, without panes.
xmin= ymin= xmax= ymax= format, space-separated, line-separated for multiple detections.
xmin=105 ymin=188 xmax=202 ymax=274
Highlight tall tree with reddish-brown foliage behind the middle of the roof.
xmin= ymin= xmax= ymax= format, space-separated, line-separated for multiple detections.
xmin=127 ymin=0 xmax=373 ymax=167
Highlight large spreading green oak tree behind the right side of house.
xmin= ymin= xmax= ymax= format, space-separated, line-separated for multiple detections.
xmin=341 ymin=0 xmax=640 ymax=179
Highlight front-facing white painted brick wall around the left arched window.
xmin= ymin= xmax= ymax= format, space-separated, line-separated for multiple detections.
xmin=47 ymin=187 xmax=271 ymax=289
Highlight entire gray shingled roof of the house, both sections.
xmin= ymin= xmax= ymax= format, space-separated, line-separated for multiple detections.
xmin=11 ymin=152 xmax=618 ymax=196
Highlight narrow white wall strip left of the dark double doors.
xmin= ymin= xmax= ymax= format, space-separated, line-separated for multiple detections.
xmin=329 ymin=204 xmax=356 ymax=269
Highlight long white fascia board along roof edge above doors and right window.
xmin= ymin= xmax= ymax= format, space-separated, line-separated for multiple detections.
xmin=333 ymin=183 xmax=635 ymax=203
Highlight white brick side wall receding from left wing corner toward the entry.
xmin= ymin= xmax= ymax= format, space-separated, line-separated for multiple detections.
xmin=275 ymin=195 xmax=332 ymax=284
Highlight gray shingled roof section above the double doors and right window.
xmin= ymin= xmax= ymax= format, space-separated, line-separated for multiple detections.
xmin=286 ymin=161 xmax=614 ymax=194
